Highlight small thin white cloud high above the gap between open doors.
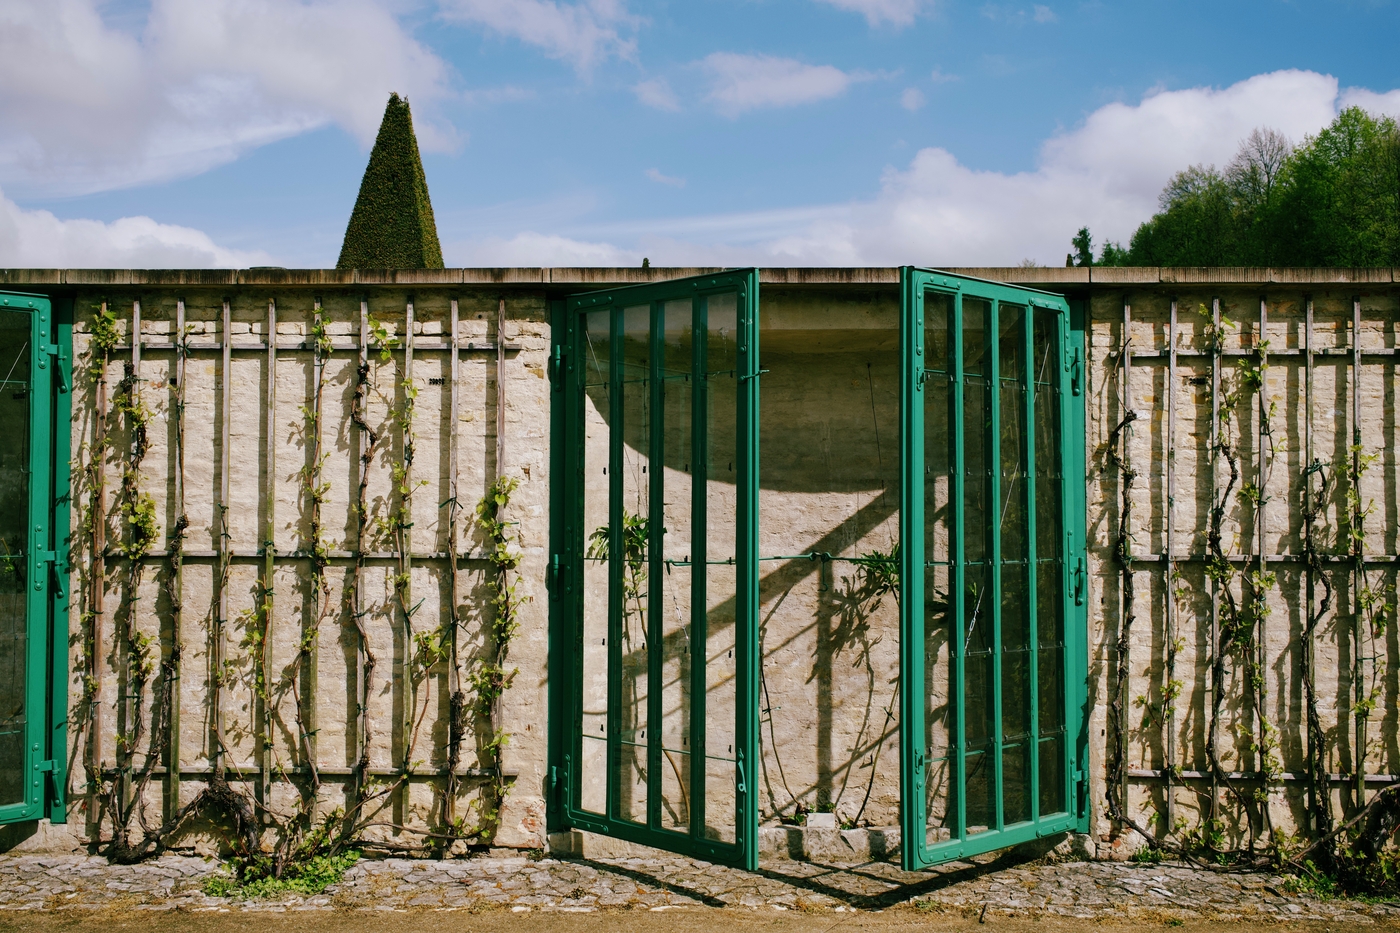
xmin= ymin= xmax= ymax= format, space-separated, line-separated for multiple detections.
xmin=701 ymin=52 xmax=855 ymax=116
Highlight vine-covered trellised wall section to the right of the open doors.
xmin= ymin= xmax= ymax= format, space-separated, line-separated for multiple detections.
xmin=1086 ymin=270 xmax=1400 ymax=848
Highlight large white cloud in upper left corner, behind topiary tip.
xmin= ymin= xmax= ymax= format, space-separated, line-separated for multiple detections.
xmin=0 ymin=0 xmax=451 ymax=195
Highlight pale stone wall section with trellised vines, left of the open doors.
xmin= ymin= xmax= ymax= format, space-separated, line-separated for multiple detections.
xmin=60 ymin=275 xmax=549 ymax=846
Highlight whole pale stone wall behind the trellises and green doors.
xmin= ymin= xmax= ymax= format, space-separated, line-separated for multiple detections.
xmin=3 ymin=269 xmax=1400 ymax=850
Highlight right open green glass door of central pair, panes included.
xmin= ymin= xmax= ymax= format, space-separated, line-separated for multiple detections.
xmin=900 ymin=268 xmax=1086 ymax=869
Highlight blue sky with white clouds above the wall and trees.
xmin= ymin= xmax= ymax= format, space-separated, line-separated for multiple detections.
xmin=0 ymin=0 xmax=1400 ymax=266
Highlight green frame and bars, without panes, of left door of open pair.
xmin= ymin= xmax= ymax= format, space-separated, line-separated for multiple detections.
xmin=547 ymin=269 xmax=759 ymax=870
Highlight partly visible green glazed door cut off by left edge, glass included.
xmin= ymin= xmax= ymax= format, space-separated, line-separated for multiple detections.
xmin=0 ymin=291 xmax=73 ymax=822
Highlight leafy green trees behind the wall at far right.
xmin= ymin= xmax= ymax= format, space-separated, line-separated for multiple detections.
xmin=1065 ymin=108 xmax=1400 ymax=268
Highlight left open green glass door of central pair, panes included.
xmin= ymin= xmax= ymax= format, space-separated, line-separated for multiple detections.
xmin=550 ymin=270 xmax=759 ymax=869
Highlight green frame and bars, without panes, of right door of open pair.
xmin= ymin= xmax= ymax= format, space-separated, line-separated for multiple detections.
xmin=900 ymin=266 xmax=1088 ymax=870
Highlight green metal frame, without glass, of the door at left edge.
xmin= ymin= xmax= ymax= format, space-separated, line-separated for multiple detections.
xmin=0 ymin=291 xmax=73 ymax=824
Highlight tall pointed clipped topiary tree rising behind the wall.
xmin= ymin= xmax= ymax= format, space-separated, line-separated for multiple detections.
xmin=336 ymin=94 xmax=442 ymax=269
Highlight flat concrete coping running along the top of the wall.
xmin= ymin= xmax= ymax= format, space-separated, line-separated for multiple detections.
xmin=0 ymin=266 xmax=1400 ymax=289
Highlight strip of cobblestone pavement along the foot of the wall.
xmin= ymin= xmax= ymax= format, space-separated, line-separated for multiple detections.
xmin=0 ymin=856 xmax=1400 ymax=925
